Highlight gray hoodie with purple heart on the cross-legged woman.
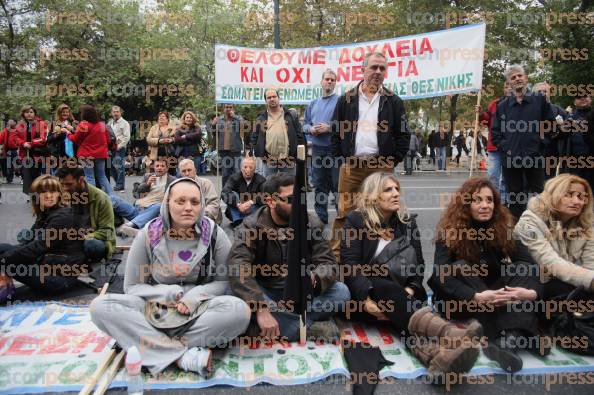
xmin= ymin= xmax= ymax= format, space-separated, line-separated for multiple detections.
xmin=124 ymin=178 xmax=231 ymax=312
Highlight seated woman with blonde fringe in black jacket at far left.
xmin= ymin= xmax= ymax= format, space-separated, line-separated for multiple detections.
xmin=0 ymin=175 xmax=87 ymax=294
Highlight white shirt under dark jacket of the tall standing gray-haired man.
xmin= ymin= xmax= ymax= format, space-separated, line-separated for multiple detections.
xmin=355 ymin=84 xmax=380 ymax=156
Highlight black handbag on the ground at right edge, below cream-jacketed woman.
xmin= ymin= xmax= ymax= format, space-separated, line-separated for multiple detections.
xmin=552 ymin=287 xmax=594 ymax=355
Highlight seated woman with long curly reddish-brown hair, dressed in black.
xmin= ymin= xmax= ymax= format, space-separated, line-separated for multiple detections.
xmin=428 ymin=178 xmax=542 ymax=372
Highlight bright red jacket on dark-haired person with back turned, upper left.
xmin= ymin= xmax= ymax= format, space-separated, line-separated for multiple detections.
xmin=68 ymin=121 xmax=109 ymax=159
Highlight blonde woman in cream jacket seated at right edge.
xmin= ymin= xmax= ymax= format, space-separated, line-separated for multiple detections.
xmin=514 ymin=174 xmax=594 ymax=300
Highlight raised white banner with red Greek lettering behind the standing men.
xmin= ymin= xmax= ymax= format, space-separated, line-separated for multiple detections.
xmin=215 ymin=23 xmax=486 ymax=104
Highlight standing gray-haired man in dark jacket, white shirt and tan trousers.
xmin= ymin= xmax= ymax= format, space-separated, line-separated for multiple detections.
xmin=332 ymin=52 xmax=410 ymax=257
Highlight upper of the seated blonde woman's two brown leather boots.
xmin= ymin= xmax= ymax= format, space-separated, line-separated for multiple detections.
xmin=408 ymin=307 xmax=483 ymax=348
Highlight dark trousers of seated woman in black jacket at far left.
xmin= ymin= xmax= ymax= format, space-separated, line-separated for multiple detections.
xmin=0 ymin=244 xmax=78 ymax=295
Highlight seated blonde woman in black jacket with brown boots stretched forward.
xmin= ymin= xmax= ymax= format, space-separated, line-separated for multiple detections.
xmin=340 ymin=172 xmax=481 ymax=375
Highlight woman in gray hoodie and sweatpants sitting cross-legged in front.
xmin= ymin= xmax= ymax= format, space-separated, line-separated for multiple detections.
xmin=90 ymin=178 xmax=250 ymax=376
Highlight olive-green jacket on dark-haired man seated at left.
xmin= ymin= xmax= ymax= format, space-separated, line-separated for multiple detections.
xmin=87 ymin=184 xmax=116 ymax=258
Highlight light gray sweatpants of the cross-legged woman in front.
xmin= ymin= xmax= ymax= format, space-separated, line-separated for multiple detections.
xmin=90 ymin=294 xmax=250 ymax=374
